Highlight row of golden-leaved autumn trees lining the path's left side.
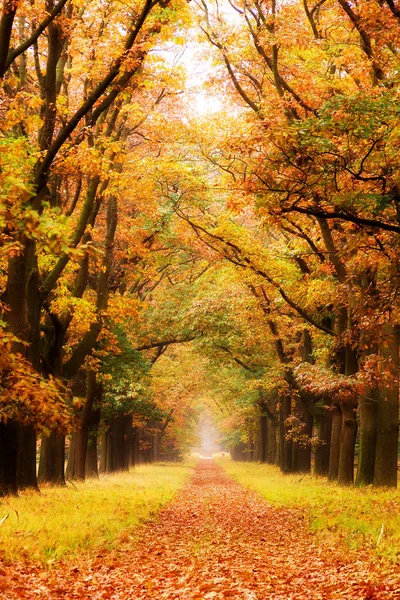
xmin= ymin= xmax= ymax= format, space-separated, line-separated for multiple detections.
xmin=0 ymin=0 xmax=205 ymax=493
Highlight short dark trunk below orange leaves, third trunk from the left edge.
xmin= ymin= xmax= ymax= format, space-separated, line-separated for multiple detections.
xmin=39 ymin=431 xmax=65 ymax=485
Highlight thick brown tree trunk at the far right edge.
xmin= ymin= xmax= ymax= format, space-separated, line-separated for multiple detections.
xmin=374 ymin=325 xmax=400 ymax=487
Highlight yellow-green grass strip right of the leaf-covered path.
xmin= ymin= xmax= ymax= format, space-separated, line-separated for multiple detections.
xmin=217 ymin=458 xmax=400 ymax=562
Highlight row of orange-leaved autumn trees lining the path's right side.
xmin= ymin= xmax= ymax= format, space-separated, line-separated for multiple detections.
xmin=185 ymin=0 xmax=400 ymax=486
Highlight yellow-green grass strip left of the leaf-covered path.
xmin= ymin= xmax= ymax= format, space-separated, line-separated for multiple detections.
xmin=0 ymin=464 xmax=192 ymax=565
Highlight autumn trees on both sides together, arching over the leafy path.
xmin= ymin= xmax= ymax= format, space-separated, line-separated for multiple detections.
xmin=0 ymin=0 xmax=400 ymax=493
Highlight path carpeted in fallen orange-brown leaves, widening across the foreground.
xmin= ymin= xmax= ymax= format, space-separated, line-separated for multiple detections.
xmin=0 ymin=460 xmax=400 ymax=600
